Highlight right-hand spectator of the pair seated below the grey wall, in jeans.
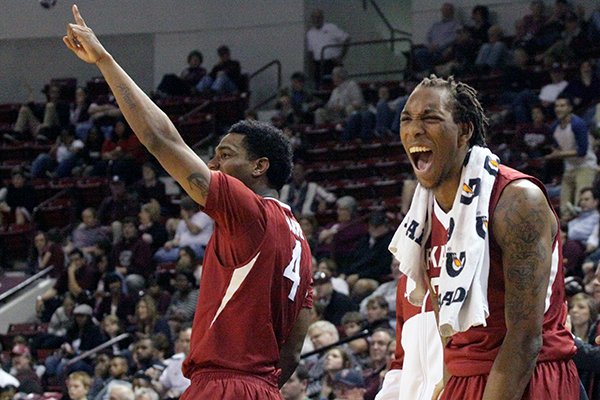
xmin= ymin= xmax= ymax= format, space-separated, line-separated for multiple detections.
xmin=196 ymin=46 xmax=242 ymax=94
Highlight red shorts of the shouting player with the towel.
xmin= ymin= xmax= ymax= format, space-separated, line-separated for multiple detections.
xmin=442 ymin=360 xmax=579 ymax=400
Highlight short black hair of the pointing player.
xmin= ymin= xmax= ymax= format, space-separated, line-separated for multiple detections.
xmin=227 ymin=120 xmax=293 ymax=190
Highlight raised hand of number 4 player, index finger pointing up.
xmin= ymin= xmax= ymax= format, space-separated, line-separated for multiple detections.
xmin=63 ymin=5 xmax=108 ymax=64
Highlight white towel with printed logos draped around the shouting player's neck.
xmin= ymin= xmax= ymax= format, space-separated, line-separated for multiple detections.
xmin=389 ymin=146 xmax=499 ymax=336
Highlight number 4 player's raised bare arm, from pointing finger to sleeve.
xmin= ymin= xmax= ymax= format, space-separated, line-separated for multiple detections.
xmin=63 ymin=5 xmax=210 ymax=205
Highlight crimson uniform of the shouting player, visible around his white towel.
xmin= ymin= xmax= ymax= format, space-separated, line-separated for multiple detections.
xmin=427 ymin=165 xmax=579 ymax=400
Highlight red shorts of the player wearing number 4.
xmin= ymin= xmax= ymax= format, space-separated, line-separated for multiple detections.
xmin=179 ymin=372 xmax=281 ymax=400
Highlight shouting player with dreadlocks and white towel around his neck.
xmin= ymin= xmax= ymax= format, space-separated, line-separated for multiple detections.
xmin=378 ymin=75 xmax=579 ymax=400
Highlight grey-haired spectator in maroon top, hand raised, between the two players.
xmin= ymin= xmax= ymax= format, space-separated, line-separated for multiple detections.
xmin=317 ymin=196 xmax=367 ymax=274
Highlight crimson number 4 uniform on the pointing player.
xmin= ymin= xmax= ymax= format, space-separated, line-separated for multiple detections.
xmin=181 ymin=172 xmax=312 ymax=400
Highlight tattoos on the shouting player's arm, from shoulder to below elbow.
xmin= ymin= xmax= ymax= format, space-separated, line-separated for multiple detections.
xmin=494 ymin=186 xmax=552 ymax=326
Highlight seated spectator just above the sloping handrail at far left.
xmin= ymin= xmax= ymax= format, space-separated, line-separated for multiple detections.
xmin=30 ymin=229 xmax=65 ymax=278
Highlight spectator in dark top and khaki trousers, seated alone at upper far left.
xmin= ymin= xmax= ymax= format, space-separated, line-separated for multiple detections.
xmin=4 ymin=85 xmax=69 ymax=141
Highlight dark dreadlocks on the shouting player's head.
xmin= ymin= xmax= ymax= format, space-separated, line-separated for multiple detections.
xmin=419 ymin=74 xmax=489 ymax=147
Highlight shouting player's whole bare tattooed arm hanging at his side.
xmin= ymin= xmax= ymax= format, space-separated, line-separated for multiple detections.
xmin=483 ymin=180 xmax=558 ymax=400
